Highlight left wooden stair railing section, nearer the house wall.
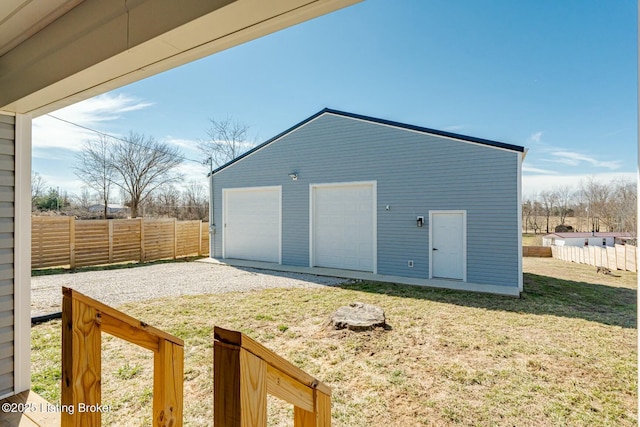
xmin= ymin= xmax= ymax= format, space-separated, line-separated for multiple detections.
xmin=61 ymin=288 xmax=184 ymax=427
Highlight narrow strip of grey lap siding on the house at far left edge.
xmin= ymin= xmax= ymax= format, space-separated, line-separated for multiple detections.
xmin=0 ymin=114 xmax=15 ymax=396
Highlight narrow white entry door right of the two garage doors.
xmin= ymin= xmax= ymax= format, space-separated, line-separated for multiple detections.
xmin=429 ymin=211 xmax=467 ymax=281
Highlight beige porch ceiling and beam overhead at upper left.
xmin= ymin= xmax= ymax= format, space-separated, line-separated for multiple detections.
xmin=0 ymin=0 xmax=361 ymax=116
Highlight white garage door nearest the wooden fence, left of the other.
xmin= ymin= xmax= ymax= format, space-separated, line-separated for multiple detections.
xmin=223 ymin=187 xmax=281 ymax=263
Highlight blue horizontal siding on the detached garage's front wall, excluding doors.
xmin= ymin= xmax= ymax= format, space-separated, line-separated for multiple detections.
xmin=214 ymin=114 xmax=520 ymax=287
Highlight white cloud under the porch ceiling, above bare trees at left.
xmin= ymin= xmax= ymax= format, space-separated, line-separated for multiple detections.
xmin=32 ymin=93 xmax=152 ymax=157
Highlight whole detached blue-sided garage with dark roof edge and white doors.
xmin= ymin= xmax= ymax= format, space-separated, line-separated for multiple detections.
xmin=211 ymin=109 xmax=525 ymax=295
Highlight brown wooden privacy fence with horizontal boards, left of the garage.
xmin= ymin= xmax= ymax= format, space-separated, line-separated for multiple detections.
xmin=31 ymin=216 xmax=209 ymax=268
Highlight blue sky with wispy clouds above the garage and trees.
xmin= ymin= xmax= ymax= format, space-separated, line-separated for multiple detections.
xmin=33 ymin=0 xmax=638 ymax=201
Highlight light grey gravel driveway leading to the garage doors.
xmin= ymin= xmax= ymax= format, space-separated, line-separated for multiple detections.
xmin=31 ymin=262 xmax=347 ymax=317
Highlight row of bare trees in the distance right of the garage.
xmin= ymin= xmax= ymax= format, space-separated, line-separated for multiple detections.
xmin=522 ymin=177 xmax=638 ymax=234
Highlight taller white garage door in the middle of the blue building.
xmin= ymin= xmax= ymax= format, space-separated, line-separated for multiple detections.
xmin=311 ymin=183 xmax=376 ymax=272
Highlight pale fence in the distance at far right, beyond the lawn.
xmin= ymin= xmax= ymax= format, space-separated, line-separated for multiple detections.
xmin=551 ymin=245 xmax=638 ymax=271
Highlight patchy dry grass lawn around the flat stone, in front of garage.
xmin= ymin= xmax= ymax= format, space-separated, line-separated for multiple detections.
xmin=32 ymin=258 xmax=638 ymax=426
